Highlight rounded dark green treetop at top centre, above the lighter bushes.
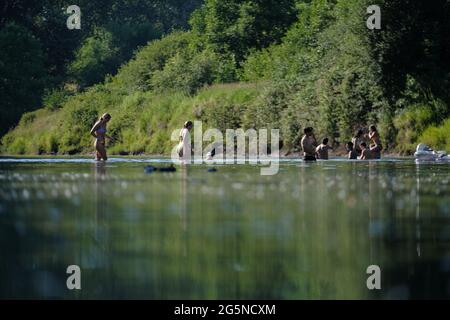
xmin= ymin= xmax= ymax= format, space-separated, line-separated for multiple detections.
xmin=191 ymin=0 xmax=296 ymax=62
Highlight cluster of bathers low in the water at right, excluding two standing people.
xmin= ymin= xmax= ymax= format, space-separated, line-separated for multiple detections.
xmin=301 ymin=125 xmax=383 ymax=161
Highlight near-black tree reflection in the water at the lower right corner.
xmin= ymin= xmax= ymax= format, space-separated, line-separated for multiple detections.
xmin=372 ymin=165 xmax=449 ymax=299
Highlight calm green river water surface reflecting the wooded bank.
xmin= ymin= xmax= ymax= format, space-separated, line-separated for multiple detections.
xmin=0 ymin=158 xmax=450 ymax=299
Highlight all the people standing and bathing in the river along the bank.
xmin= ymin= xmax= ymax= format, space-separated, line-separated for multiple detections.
xmin=90 ymin=113 xmax=383 ymax=161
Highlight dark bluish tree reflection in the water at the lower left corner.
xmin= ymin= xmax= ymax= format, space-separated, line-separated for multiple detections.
xmin=0 ymin=168 xmax=71 ymax=299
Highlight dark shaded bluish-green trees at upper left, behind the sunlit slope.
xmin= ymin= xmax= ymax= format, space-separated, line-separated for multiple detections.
xmin=0 ymin=0 xmax=201 ymax=135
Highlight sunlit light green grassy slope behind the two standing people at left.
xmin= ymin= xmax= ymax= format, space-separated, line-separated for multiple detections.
xmin=2 ymin=84 xmax=260 ymax=155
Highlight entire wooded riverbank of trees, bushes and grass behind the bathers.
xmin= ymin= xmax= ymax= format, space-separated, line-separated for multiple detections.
xmin=0 ymin=0 xmax=450 ymax=154
